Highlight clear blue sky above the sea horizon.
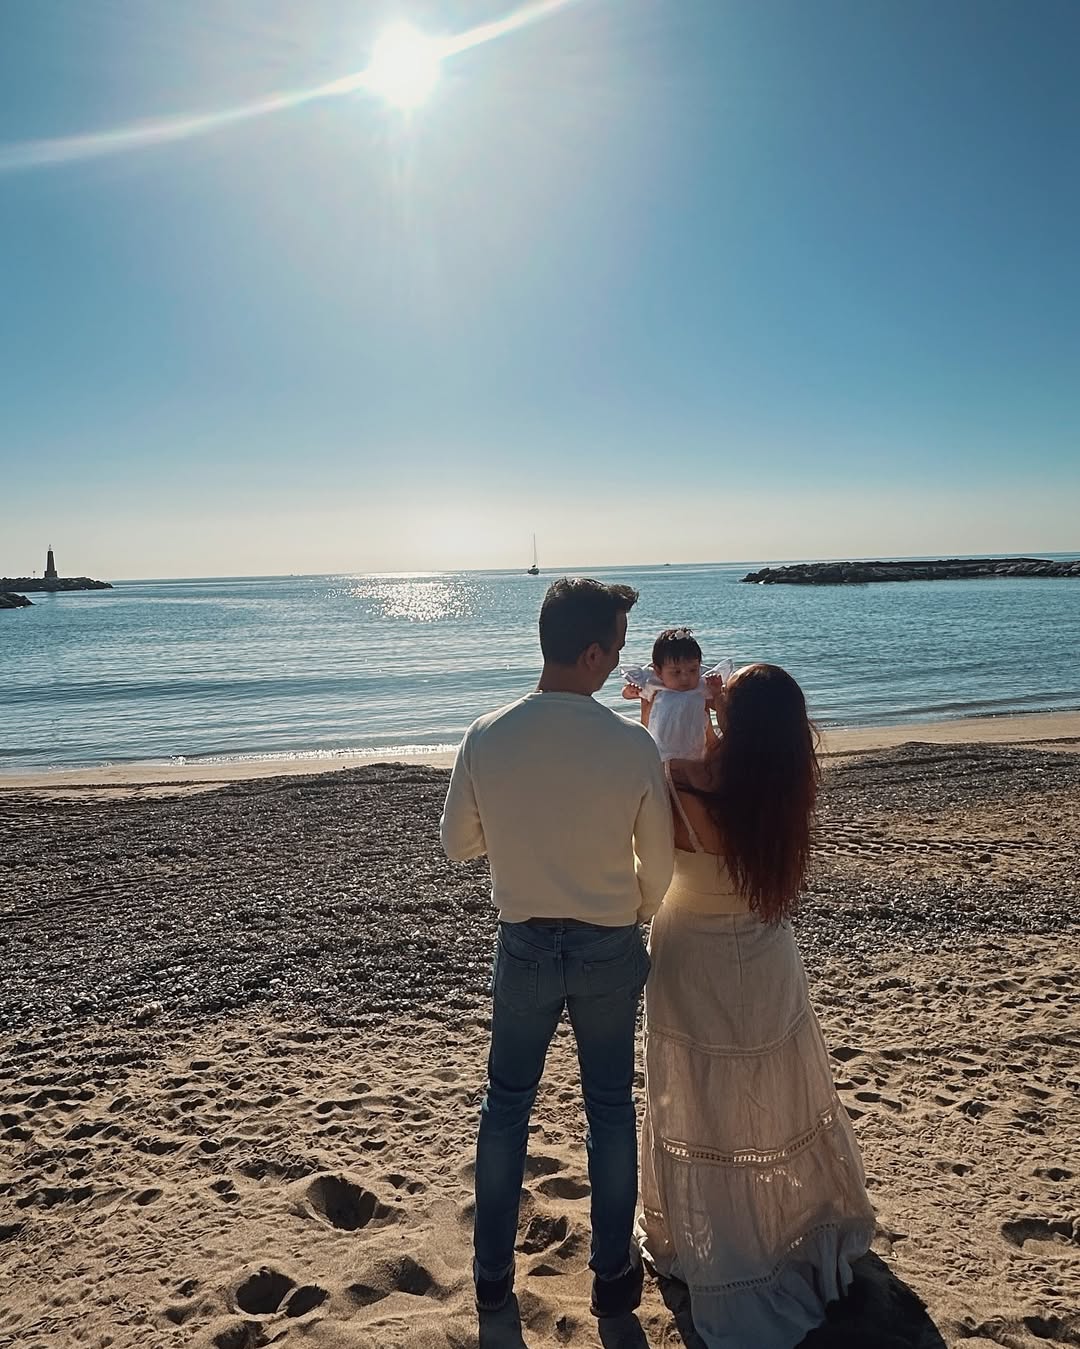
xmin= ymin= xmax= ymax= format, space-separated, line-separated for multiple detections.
xmin=0 ymin=0 xmax=1080 ymax=577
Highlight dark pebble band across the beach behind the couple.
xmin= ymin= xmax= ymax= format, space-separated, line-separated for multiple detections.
xmin=0 ymin=745 xmax=1080 ymax=1031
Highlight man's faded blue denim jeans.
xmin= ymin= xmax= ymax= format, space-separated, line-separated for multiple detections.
xmin=473 ymin=919 xmax=649 ymax=1279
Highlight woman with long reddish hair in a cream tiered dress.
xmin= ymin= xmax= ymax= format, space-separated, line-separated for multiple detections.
xmin=638 ymin=665 xmax=874 ymax=1349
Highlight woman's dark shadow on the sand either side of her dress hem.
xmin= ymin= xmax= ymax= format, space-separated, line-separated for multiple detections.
xmin=661 ymin=1253 xmax=945 ymax=1349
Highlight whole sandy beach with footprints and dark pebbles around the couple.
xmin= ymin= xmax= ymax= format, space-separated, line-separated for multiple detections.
xmin=0 ymin=714 xmax=1080 ymax=1349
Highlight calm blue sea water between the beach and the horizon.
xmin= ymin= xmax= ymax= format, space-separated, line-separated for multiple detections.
xmin=0 ymin=563 xmax=1080 ymax=772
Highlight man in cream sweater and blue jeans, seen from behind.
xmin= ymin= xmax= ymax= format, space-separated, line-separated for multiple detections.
xmin=442 ymin=577 xmax=674 ymax=1317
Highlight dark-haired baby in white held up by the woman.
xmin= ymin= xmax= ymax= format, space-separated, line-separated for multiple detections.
xmin=622 ymin=627 xmax=735 ymax=762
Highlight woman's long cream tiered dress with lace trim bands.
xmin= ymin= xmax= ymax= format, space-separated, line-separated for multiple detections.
xmin=638 ymin=792 xmax=874 ymax=1349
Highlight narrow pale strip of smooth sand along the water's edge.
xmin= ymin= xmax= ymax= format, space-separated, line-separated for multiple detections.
xmin=0 ymin=711 xmax=1080 ymax=793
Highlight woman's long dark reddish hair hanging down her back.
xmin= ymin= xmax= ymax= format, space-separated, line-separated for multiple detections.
xmin=690 ymin=665 xmax=821 ymax=923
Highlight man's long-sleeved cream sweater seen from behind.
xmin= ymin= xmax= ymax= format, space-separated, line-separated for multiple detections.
xmin=441 ymin=693 xmax=674 ymax=927
